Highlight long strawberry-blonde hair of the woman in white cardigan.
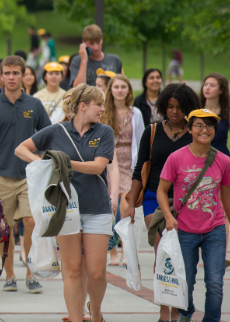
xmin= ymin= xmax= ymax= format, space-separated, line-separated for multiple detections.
xmin=101 ymin=74 xmax=133 ymax=137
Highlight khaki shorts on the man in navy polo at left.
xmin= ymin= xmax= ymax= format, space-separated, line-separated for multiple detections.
xmin=0 ymin=176 xmax=32 ymax=227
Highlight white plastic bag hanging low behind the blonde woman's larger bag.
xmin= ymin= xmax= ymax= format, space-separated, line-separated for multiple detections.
xmin=27 ymin=228 xmax=61 ymax=279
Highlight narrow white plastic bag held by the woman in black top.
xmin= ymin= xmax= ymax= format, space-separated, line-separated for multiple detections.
xmin=114 ymin=217 xmax=143 ymax=291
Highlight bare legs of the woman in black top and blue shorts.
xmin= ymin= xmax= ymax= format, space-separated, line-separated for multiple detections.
xmin=145 ymin=214 xmax=179 ymax=321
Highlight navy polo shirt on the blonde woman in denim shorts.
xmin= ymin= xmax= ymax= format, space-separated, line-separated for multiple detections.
xmin=32 ymin=121 xmax=114 ymax=215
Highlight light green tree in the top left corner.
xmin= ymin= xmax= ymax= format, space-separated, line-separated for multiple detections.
xmin=0 ymin=0 xmax=34 ymax=55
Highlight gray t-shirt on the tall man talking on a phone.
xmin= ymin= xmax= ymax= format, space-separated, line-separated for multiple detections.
xmin=70 ymin=53 xmax=122 ymax=86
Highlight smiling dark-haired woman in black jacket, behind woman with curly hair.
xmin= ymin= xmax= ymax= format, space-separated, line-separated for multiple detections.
xmin=133 ymin=68 xmax=163 ymax=127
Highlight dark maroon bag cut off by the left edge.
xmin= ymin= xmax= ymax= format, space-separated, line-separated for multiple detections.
xmin=0 ymin=199 xmax=10 ymax=276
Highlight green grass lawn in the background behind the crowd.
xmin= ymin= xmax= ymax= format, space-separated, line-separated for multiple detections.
xmin=0 ymin=11 xmax=230 ymax=80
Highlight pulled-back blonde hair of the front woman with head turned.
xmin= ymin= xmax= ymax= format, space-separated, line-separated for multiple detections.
xmin=67 ymin=84 xmax=105 ymax=114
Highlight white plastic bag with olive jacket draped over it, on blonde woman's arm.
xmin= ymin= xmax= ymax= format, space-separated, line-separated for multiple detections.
xmin=26 ymin=160 xmax=80 ymax=236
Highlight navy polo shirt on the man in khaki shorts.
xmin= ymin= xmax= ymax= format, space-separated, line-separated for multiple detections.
xmin=0 ymin=91 xmax=51 ymax=179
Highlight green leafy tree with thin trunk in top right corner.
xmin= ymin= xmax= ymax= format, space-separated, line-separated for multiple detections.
xmin=169 ymin=0 xmax=230 ymax=81
